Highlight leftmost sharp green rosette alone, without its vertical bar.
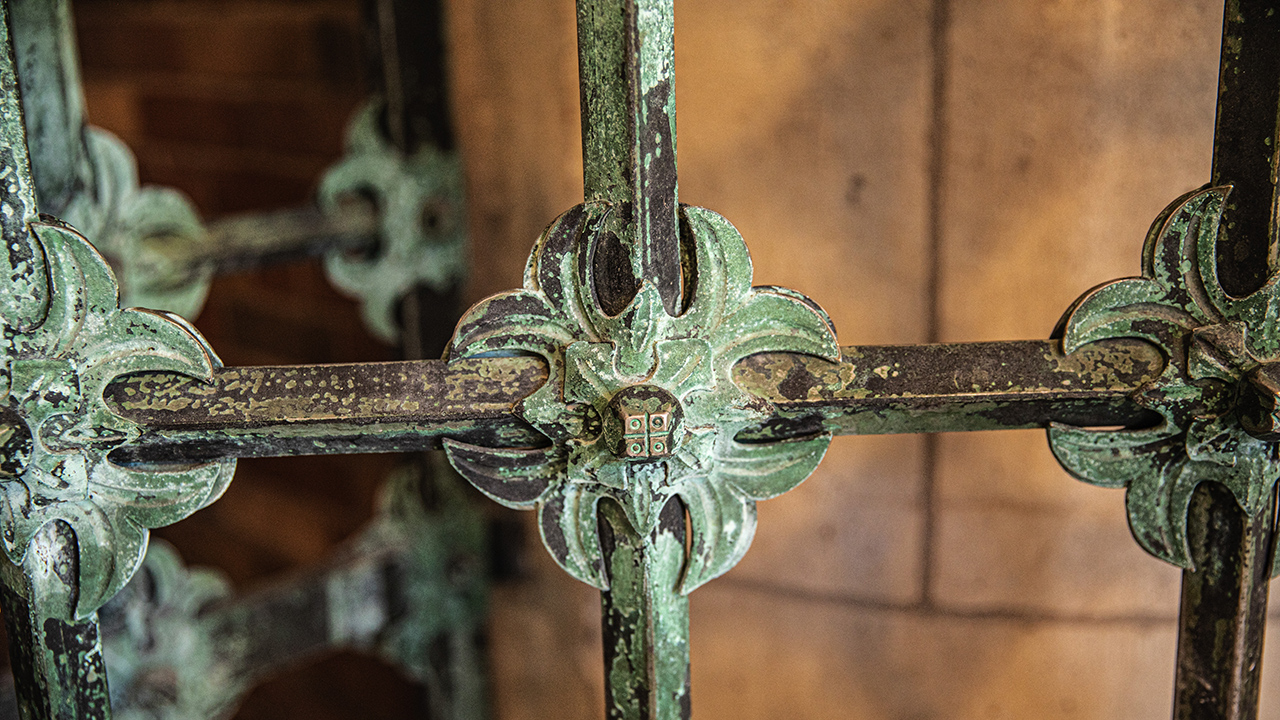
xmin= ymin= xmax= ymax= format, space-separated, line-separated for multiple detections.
xmin=0 ymin=211 xmax=236 ymax=620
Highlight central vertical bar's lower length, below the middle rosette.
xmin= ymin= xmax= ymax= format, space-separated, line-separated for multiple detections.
xmin=600 ymin=500 xmax=691 ymax=720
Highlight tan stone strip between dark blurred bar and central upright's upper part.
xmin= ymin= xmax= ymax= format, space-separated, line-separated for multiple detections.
xmin=448 ymin=0 xmax=582 ymax=300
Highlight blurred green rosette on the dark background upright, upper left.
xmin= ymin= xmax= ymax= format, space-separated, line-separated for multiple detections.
xmin=319 ymin=100 xmax=467 ymax=342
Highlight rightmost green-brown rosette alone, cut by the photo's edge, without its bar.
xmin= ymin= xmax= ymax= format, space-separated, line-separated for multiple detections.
xmin=1050 ymin=187 xmax=1280 ymax=574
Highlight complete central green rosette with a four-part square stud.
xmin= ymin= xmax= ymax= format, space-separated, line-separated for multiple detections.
xmin=445 ymin=202 xmax=840 ymax=593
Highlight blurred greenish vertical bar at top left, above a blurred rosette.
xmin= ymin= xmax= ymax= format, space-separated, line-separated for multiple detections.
xmin=8 ymin=0 xmax=90 ymax=215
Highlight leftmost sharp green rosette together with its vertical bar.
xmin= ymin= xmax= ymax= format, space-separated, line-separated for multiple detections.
xmin=0 ymin=5 xmax=234 ymax=717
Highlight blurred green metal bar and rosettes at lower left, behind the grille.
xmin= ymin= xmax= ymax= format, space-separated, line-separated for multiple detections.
xmin=101 ymin=454 xmax=488 ymax=720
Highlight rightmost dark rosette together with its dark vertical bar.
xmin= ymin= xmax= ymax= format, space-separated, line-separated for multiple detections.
xmin=1050 ymin=0 xmax=1280 ymax=720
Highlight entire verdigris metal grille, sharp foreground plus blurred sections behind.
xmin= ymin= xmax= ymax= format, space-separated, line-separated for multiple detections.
xmin=0 ymin=0 xmax=1280 ymax=720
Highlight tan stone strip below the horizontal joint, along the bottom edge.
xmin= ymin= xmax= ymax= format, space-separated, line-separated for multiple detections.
xmin=692 ymin=588 xmax=1174 ymax=720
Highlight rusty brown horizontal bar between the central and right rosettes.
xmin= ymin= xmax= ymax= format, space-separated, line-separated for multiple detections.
xmin=733 ymin=340 xmax=1164 ymax=441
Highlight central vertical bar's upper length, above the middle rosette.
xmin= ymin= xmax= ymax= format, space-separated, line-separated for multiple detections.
xmin=577 ymin=0 xmax=682 ymax=315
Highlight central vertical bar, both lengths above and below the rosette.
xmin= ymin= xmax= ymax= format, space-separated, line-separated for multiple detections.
xmin=577 ymin=0 xmax=691 ymax=720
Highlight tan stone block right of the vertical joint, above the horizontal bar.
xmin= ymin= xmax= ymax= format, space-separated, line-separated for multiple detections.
xmin=941 ymin=0 xmax=1222 ymax=341
